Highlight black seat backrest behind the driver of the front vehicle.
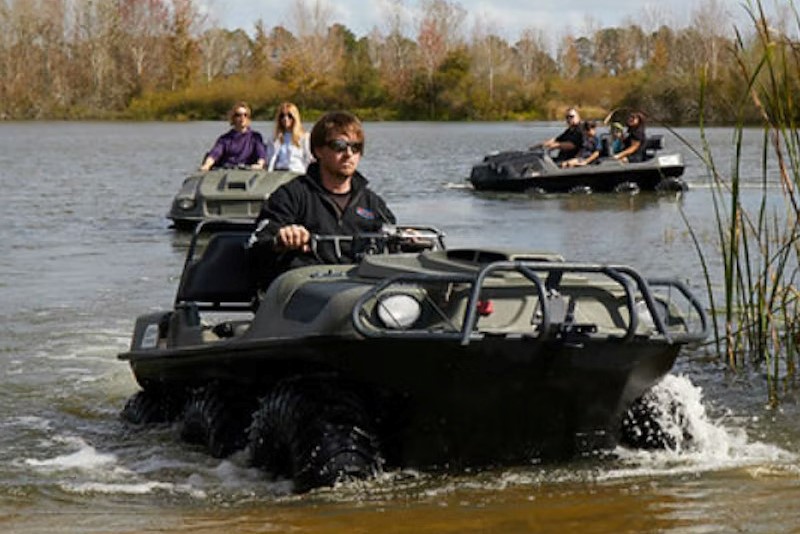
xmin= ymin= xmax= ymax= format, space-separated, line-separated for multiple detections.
xmin=175 ymin=232 xmax=256 ymax=309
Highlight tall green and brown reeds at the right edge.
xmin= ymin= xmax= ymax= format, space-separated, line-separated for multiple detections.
xmin=695 ymin=1 xmax=800 ymax=405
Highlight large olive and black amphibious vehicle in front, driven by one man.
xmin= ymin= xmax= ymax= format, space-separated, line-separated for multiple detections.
xmin=119 ymin=222 xmax=707 ymax=492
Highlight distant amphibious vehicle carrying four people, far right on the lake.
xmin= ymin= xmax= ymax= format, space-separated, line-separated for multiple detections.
xmin=470 ymin=135 xmax=688 ymax=193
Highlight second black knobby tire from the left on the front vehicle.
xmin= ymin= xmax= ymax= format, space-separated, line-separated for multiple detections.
xmin=181 ymin=386 xmax=251 ymax=458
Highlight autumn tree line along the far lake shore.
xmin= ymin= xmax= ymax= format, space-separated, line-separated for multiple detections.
xmin=0 ymin=0 xmax=800 ymax=124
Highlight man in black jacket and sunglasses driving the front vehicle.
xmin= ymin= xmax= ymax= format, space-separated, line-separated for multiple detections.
xmin=250 ymin=111 xmax=396 ymax=276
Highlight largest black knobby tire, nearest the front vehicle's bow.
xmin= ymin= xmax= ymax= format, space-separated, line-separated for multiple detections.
xmin=249 ymin=380 xmax=382 ymax=493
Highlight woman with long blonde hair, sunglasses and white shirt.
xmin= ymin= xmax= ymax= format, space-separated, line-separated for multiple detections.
xmin=267 ymin=102 xmax=314 ymax=173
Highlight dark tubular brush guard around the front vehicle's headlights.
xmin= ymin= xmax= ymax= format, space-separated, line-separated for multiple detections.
xmin=352 ymin=261 xmax=709 ymax=346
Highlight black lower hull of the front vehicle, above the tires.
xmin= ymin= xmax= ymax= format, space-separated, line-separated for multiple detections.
xmin=121 ymin=337 xmax=680 ymax=469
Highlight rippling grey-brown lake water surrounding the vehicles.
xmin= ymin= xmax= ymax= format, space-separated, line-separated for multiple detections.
xmin=0 ymin=122 xmax=800 ymax=533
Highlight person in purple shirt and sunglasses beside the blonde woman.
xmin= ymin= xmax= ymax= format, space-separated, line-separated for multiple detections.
xmin=200 ymin=101 xmax=267 ymax=171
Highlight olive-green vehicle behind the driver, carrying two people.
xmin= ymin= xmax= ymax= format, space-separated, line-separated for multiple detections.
xmin=167 ymin=168 xmax=298 ymax=229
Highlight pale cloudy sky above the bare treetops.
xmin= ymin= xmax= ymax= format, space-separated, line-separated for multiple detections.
xmin=203 ymin=0 xmax=756 ymax=40
